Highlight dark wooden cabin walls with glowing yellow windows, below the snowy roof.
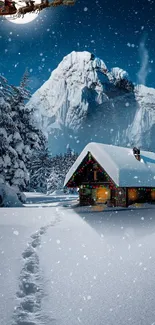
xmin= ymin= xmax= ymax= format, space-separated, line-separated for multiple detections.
xmin=67 ymin=152 xmax=155 ymax=207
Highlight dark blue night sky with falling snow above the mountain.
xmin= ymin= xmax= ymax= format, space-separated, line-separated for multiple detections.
xmin=0 ymin=0 xmax=155 ymax=93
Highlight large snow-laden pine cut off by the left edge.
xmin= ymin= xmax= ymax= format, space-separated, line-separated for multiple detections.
xmin=0 ymin=76 xmax=29 ymax=190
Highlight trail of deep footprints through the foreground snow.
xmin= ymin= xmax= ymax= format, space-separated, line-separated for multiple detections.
xmin=13 ymin=210 xmax=61 ymax=325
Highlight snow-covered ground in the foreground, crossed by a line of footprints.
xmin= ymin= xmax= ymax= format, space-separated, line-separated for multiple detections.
xmin=0 ymin=194 xmax=155 ymax=325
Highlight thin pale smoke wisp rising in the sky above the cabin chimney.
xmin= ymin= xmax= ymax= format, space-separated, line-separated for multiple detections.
xmin=137 ymin=36 xmax=149 ymax=85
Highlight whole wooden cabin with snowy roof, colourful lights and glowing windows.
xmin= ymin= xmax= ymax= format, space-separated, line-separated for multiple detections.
xmin=64 ymin=143 xmax=155 ymax=207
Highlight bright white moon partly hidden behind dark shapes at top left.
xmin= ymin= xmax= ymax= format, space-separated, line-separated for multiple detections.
xmin=5 ymin=0 xmax=41 ymax=24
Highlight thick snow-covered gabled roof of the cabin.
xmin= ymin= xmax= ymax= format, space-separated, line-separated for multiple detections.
xmin=64 ymin=142 xmax=155 ymax=187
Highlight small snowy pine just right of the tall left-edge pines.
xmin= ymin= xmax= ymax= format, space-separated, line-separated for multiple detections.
xmin=29 ymin=148 xmax=51 ymax=193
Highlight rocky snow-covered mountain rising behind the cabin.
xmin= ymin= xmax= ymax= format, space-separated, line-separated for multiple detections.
xmin=27 ymin=52 xmax=155 ymax=153
